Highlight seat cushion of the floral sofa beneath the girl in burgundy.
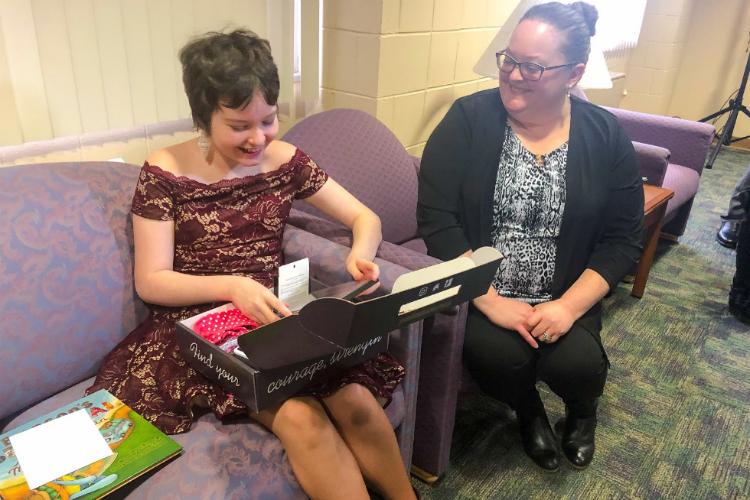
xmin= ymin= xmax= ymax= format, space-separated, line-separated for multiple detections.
xmin=0 ymin=379 xmax=404 ymax=500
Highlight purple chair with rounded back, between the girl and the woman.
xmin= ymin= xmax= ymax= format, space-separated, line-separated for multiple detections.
xmin=282 ymin=109 xmax=467 ymax=476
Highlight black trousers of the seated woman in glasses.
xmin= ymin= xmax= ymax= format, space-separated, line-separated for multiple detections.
xmin=463 ymin=306 xmax=607 ymax=418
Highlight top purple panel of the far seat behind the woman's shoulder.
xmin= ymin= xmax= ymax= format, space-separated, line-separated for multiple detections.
xmin=606 ymin=108 xmax=715 ymax=174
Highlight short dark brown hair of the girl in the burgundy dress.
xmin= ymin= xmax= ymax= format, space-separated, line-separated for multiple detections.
xmin=180 ymin=29 xmax=279 ymax=134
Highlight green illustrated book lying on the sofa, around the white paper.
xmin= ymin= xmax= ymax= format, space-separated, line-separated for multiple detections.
xmin=0 ymin=390 xmax=182 ymax=500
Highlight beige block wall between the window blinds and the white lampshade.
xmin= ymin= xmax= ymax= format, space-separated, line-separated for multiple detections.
xmin=321 ymin=0 xmax=518 ymax=156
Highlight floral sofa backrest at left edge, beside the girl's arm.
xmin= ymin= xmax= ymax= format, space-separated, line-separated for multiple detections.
xmin=0 ymin=162 xmax=146 ymax=418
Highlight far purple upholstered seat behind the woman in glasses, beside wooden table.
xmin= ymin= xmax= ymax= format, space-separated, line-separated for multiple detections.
xmin=574 ymin=89 xmax=715 ymax=240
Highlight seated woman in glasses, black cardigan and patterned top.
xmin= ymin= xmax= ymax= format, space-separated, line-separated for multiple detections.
xmin=417 ymin=2 xmax=644 ymax=471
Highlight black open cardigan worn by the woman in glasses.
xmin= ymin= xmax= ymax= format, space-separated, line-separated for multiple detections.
xmin=417 ymin=88 xmax=644 ymax=338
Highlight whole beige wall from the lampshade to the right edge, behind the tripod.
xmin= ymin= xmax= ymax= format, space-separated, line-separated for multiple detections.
xmin=610 ymin=0 xmax=750 ymax=141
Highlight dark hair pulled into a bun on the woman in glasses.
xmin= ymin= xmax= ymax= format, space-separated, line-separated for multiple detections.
xmin=519 ymin=2 xmax=599 ymax=64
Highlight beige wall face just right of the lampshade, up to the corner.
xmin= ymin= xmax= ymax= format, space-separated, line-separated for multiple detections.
xmin=620 ymin=0 xmax=693 ymax=115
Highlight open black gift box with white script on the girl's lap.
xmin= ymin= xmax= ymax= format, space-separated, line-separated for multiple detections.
xmin=177 ymin=247 xmax=502 ymax=412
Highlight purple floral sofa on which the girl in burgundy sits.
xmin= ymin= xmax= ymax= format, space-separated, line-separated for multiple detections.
xmin=0 ymin=162 xmax=422 ymax=500
